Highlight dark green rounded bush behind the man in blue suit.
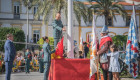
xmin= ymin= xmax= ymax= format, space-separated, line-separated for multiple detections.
xmin=0 ymin=27 xmax=25 ymax=51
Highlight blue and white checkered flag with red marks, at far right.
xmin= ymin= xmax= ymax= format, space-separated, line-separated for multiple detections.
xmin=125 ymin=4 xmax=139 ymax=78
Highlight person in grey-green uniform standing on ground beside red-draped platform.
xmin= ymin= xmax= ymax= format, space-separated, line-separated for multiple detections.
xmin=43 ymin=37 xmax=55 ymax=80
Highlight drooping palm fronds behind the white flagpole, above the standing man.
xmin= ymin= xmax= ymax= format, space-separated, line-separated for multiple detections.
xmin=35 ymin=0 xmax=88 ymax=24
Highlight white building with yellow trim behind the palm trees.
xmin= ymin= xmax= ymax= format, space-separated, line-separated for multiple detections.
xmin=0 ymin=0 xmax=140 ymax=48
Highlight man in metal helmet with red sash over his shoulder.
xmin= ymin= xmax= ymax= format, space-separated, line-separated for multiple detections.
xmin=97 ymin=25 xmax=113 ymax=80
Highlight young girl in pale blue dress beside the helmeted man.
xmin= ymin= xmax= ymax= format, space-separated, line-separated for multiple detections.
xmin=107 ymin=44 xmax=121 ymax=80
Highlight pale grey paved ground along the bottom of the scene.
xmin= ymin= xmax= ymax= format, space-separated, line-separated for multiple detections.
xmin=0 ymin=72 xmax=140 ymax=80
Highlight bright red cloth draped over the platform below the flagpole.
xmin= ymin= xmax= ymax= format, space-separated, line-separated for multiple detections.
xmin=49 ymin=59 xmax=95 ymax=80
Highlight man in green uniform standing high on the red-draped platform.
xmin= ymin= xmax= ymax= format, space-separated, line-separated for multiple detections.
xmin=52 ymin=13 xmax=66 ymax=47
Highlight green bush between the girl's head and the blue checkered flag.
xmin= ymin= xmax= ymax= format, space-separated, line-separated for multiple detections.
xmin=112 ymin=35 xmax=127 ymax=48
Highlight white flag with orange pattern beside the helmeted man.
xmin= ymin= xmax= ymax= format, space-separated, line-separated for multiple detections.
xmin=90 ymin=15 xmax=98 ymax=78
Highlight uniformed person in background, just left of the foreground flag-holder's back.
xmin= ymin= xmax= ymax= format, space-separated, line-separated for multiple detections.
xmin=38 ymin=49 xmax=44 ymax=73
